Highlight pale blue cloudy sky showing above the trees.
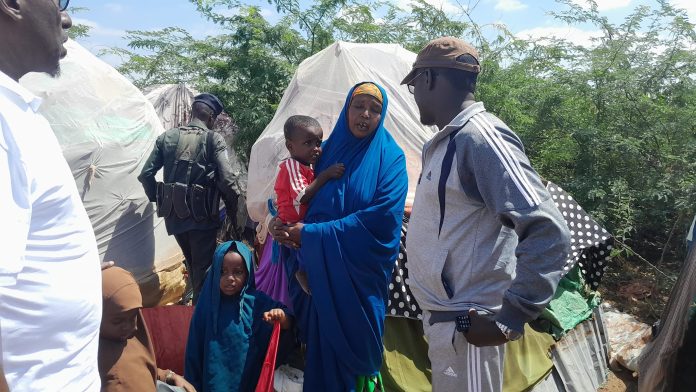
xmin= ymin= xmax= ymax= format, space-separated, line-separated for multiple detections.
xmin=70 ymin=0 xmax=696 ymax=65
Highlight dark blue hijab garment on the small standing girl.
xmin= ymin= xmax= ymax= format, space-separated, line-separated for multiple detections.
xmin=184 ymin=241 xmax=288 ymax=392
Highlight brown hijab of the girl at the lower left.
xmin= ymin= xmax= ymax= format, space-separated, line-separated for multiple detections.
xmin=98 ymin=267 xmax=157 ymax=392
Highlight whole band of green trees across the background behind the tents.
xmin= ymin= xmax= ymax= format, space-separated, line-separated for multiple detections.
xmin=113 ymin=0 xmax=696 ymax=262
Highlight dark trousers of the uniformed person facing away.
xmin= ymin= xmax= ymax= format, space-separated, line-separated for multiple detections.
xmin=174 ymin=229 xmax=217 ymax=305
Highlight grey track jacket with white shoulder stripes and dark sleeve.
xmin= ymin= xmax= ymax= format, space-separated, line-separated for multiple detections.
xmin=406 ymin=102 xmax=570 ymax=332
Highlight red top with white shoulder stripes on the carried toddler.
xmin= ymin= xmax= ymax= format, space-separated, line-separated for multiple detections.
xmin=274 ymin=158 xmax=314 ymax=223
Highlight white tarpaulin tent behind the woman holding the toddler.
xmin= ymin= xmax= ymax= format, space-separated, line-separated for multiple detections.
xmin=247 ymin=42 xmax=433 ymax=222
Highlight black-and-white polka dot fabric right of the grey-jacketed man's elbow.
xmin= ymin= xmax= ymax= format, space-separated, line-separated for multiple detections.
xmin=546 ymin=182 xmax=614 ymax=290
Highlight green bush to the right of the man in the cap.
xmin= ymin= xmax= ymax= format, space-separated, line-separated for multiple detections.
xmin=479 ymin=1 xmax=696 ymax=261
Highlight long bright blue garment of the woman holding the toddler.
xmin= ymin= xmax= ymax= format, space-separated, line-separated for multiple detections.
xmin=283 ymin=85 xmax=408 ymax=392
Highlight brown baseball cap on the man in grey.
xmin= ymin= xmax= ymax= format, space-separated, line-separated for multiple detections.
xmin=401 ymin=37 xmax=481 ymax=84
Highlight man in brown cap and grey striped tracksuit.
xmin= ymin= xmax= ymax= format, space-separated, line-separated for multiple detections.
xmin=402 ymin=37 xmax=569 ymax=391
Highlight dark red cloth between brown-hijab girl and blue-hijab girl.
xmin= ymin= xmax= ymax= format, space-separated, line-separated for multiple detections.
xmin=143 ymin=305 xmax=193 ymax=374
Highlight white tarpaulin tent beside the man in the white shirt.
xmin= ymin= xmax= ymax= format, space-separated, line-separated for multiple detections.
xmin=21 ymin=41 xmax=183 ymax=306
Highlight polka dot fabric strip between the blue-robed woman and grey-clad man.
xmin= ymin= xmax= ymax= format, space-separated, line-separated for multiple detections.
xmin=387 ymin=216 xmax=423 ymax=320
